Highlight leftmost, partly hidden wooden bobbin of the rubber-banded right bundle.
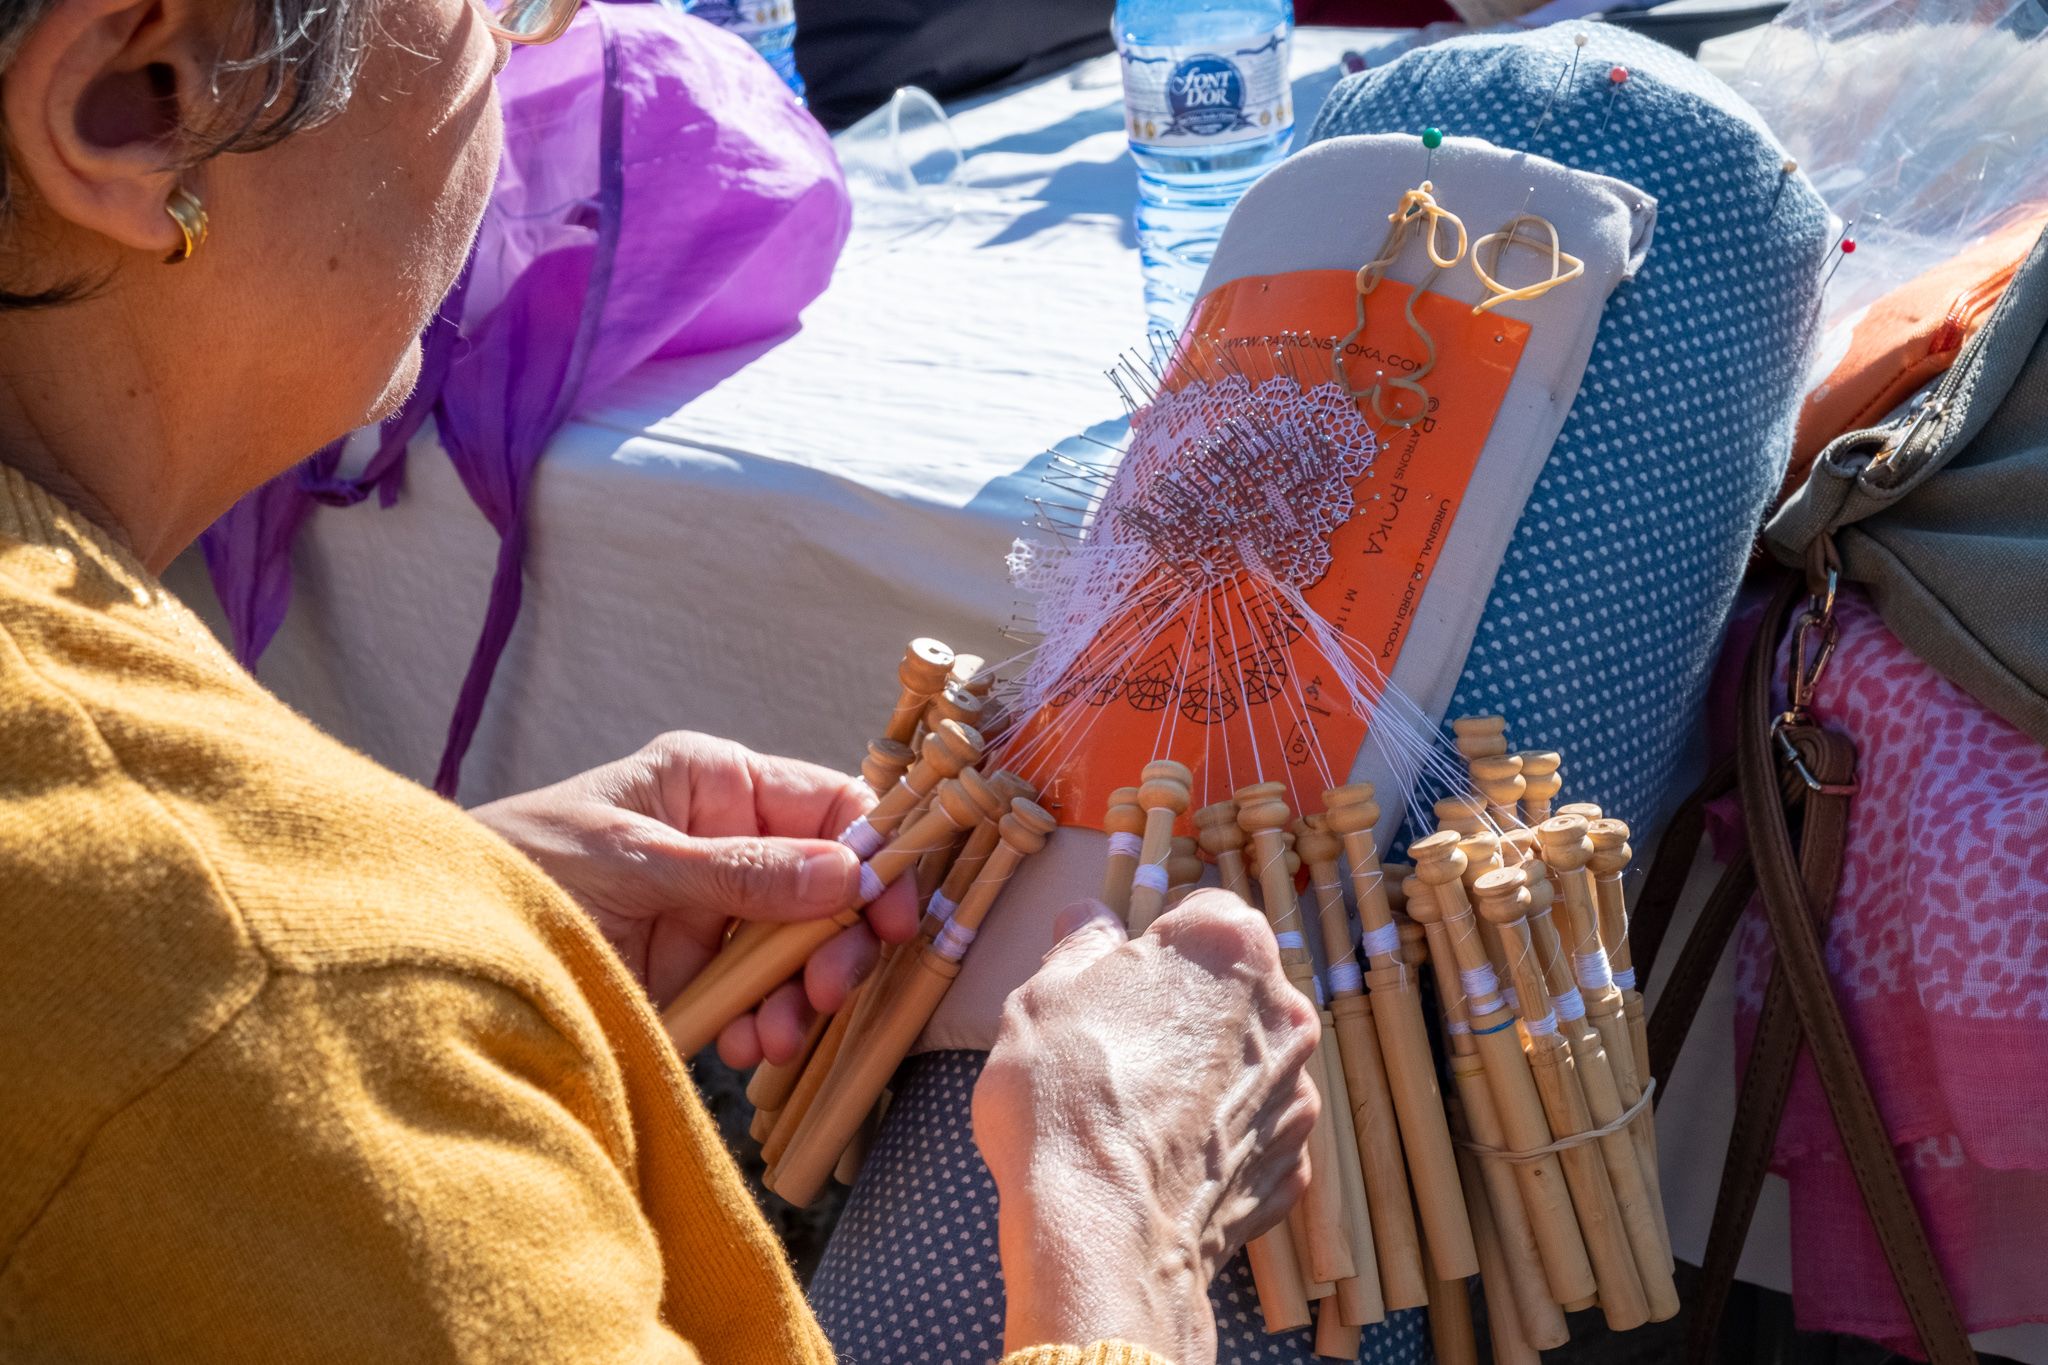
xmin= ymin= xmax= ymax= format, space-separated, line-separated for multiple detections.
xmin=1403 ymin=876 xmax=1564 ymax=1351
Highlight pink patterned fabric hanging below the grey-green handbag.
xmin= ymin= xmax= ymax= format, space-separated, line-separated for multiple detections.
xmin=1737 ymin=593 xmax=2048 ymax=1355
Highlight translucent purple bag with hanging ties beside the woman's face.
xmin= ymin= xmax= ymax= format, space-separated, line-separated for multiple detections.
xmin=203 ymin=4 xmax=850 ymax=796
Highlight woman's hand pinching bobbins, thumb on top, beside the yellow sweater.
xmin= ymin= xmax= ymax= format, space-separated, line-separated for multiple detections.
xmin=471 ymin=731 xmax=918 ymax=1068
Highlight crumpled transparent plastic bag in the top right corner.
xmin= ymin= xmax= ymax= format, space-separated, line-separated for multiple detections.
xmin=1702 ymin=0 xmax=2048 ymax=339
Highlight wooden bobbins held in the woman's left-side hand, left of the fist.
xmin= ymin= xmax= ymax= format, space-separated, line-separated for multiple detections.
xmin=664 ymin=639 xmax=1053 ymax=1203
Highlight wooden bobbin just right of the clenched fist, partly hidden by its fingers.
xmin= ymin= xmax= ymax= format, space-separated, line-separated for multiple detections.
xmin=1237 ymin=784 xmax=1358 ymax=1283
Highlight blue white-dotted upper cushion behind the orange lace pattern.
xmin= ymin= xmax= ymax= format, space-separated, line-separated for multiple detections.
xmin=1311 ymin=23 xmax=1831 ymax=835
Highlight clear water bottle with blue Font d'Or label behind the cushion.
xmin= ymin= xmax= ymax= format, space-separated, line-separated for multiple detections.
xmin=1116 ymin=0 xmax=1294 ymax=332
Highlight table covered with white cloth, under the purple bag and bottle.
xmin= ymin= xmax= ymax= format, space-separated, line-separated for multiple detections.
xmin=170 ymin=29 xmax=2048 ymax=1359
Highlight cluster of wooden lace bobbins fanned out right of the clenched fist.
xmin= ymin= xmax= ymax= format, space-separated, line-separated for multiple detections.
xmin=1102 ymin=716 xmax=1679 ymax=1365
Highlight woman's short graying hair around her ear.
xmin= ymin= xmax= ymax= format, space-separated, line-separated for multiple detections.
xmin=0 ymin=0 xmax=379 ymax=309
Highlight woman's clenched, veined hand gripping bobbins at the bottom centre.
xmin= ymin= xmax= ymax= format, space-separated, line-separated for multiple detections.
xmin=975 ymin=890 xmax=1319 ymax=1365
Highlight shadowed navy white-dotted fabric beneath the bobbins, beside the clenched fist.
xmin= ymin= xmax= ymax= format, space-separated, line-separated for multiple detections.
xmin=811 ymin=1052 xmax=1430 ymax=1365
